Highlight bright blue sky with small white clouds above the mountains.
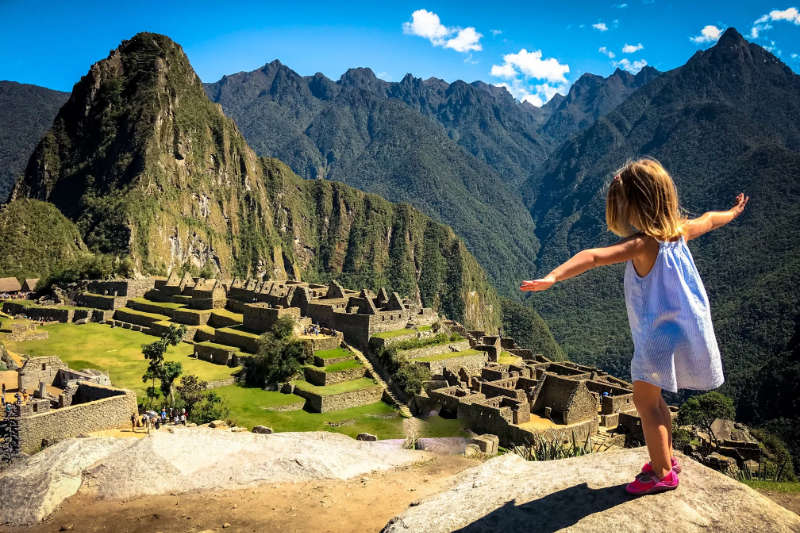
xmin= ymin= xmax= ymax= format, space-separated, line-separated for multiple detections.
xmin=0 ymin=0 xmax=800 ymax=105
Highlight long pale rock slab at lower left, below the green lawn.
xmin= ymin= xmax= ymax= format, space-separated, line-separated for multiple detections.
xmin=0 ymin=427 xmax=430 ymax=525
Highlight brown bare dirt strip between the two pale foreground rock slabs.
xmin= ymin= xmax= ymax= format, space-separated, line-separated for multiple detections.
xmin=0 ymin=450 xmax=478 ymax=533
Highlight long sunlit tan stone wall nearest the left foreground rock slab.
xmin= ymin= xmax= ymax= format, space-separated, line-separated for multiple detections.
xmin=19 ymin=384 xmax=136 ymax=453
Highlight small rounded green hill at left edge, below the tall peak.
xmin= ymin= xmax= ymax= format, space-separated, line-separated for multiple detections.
xmin=0 ymin=198 xmax=91 ymax=279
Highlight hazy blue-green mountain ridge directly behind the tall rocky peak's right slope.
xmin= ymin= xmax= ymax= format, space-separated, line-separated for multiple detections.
xmin=206 ymin=61 xmax=538 ymax=292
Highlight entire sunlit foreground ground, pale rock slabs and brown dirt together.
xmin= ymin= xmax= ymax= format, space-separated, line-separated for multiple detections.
xmin=0 ymin=428 xmax=800 ymax=533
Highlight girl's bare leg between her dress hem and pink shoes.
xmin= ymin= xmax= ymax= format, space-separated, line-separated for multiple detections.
xmin=633 ymin=381 xmax=672 ymax=479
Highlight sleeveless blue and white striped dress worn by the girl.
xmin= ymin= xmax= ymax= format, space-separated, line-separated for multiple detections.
xmin=625 ymin=237 xmax=724 ymax=392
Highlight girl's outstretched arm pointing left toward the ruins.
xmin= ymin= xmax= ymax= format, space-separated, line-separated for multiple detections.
xmin=519 ymin=234 xmax=655 ymax=291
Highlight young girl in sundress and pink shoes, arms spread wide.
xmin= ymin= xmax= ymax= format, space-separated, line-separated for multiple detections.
xmin=520 ymin=158 xmax=749 ymax=494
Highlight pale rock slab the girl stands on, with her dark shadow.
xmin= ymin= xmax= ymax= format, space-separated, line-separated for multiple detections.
xmin=384 ymin=448 xmax=800 ymax=533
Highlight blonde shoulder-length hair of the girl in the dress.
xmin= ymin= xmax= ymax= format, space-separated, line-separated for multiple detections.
xmin=606 ymin=157 xmax=686 ymax=241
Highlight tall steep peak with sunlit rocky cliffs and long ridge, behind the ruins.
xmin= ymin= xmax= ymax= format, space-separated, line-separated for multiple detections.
xmin=12 ymin=33 xmax=500 ymax=329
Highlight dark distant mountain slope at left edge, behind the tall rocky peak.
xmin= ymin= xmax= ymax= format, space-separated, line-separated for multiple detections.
xmin=0 ymin=81 xmax=69 ymax=203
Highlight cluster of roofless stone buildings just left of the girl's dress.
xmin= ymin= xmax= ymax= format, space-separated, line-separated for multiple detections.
xmin=412 ymin=332 xmax=638 ymax=446
